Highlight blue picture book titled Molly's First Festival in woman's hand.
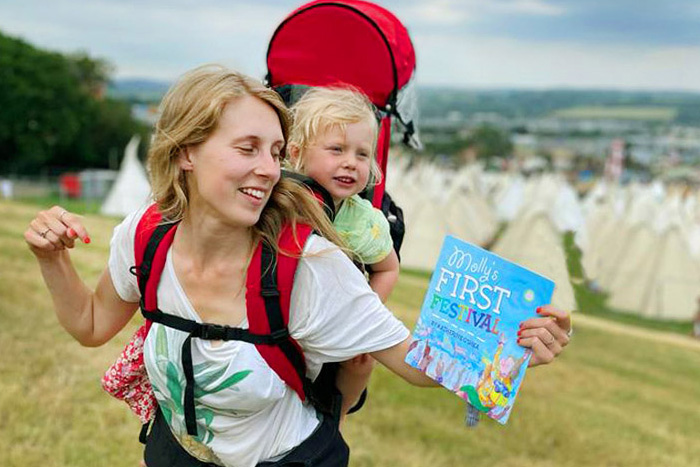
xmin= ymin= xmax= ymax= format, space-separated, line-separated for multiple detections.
xmin=406 ymin=236 xmax=554 ymax=424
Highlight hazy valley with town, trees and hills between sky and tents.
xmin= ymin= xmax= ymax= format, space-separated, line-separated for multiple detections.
xmin=108 ymin=80 xmax=700 ymax=184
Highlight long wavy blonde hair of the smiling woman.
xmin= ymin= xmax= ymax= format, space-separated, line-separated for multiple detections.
xmin=147 ymin=65 xmax=343 ymax=254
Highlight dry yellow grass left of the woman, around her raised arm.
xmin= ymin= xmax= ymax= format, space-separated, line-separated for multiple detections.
xmin=0 ymin=202 xmax=141 ymax=467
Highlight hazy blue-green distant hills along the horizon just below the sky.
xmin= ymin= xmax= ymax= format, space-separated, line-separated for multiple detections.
xmin=108 ymin=79 xmax=700 ymax=126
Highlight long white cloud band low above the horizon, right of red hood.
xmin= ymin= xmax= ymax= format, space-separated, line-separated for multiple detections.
xmin=416 ymin=31 xmax=700 ymax=91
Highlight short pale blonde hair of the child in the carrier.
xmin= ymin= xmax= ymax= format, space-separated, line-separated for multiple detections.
xmin=287 ymin=87 xmax=382 ymax=185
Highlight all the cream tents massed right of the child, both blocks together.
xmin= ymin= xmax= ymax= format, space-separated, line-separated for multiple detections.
xmin=387 ymin=159 xmax=700 ymax=320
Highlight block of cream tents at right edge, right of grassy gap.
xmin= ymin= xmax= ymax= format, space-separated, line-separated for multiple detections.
xmin=576 ymin=183 xmax=700 ymax=320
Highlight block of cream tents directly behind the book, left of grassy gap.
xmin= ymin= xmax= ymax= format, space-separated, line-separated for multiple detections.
xmin=387 ymin=158 xmax=582 ymax=316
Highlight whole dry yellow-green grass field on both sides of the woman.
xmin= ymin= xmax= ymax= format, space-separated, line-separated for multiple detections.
xmin=0 ymin=202 xmax=700 ymax=467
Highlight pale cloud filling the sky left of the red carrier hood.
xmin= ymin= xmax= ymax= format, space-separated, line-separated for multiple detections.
xmin=0 ymin=0 xmax=289 ymax=79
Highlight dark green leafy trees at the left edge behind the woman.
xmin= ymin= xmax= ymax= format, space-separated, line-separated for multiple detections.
xmin=0 ymin=33 xmax=147 ymax=174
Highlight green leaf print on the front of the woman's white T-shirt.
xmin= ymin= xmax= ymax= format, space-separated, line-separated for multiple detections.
xmin=152 ymin=326 xmax=253 ymax=444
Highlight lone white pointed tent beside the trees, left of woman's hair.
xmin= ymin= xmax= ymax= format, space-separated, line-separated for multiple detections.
xmin=100 ymin=136 xmax=151 ymax=217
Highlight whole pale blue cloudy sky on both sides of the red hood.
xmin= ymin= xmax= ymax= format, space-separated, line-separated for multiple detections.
xmin=0 ymin=0 xmax=700 ymax=92
